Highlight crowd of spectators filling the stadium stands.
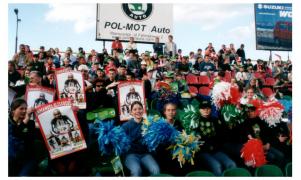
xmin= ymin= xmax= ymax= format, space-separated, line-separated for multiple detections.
xmin=8 ymin=35 xmax=292 ymax=176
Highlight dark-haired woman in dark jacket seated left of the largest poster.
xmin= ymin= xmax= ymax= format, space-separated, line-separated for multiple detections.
xmin=8 ymin=99 xmax=36 ymax=176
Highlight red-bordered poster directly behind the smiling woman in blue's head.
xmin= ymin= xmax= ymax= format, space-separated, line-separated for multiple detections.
xmin=118 ymin=81 xmax=146 ymax=121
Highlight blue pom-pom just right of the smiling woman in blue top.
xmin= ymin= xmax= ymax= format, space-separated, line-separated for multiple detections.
xmin=143 ymin=119 xmax=179 ymax=151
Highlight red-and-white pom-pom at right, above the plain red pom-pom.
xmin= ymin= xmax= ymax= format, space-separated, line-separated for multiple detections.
xmin=259 ymin=101 xmax=284 ymax=127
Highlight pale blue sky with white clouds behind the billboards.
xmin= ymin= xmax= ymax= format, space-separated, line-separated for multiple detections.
xmin=7 ymin=3 xmax=291 ymax=60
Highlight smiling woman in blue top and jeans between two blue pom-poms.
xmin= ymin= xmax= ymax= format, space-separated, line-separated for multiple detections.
xmin=122 ymin=101 xmax=160 ymax=176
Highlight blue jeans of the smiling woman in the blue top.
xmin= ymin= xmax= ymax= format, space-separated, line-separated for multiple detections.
xmin=125 ymin=154 xmax=160 ymax=176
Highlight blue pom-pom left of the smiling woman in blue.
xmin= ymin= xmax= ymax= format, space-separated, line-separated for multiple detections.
xmin=96 ymin=120 xmax=131 ymax=156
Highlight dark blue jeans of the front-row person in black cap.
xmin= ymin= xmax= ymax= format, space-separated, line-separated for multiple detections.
xmin=199 ymin=151 xmax=236 ymax=176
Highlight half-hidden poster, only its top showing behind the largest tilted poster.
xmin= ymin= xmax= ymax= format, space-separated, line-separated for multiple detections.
xmin=25 ymin=85 xmax=55 ymax=108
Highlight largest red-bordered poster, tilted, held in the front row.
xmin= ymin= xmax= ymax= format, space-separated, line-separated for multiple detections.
xmin=35 ymin=99 xmax=87 ymax=159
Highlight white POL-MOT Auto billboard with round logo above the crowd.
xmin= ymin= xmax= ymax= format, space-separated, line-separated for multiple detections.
xmin=96 ymin=3 xmax=173 ymax=43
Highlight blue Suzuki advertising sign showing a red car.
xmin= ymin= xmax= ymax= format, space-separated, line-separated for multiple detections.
xmin=254 ymin=3 xmax=292 ymax=51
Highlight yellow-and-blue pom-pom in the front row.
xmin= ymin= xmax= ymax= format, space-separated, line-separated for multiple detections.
xmin=168 ymin=131 xmax=202 ymax=168
